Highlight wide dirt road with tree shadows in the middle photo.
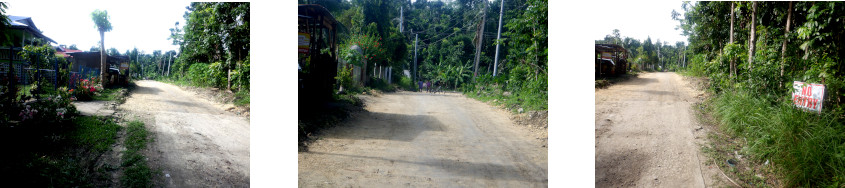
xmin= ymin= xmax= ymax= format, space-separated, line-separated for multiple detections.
xmin=298 ymin=92 xmax=548 ymax=187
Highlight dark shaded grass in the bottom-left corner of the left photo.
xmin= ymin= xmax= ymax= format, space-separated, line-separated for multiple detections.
xmin=0 ymin=116 xmax=121 ymax=187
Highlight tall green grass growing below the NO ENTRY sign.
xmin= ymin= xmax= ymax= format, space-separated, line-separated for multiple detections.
xmin=712 ymin=91 xmax=845 ymax=187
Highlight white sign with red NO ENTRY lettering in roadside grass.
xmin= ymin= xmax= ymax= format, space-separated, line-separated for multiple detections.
xmin=792 ymin=81 xmax=824 ymax=113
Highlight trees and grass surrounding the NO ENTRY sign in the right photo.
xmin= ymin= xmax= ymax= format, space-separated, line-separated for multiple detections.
xmin=673 ymin=2 xmax=845 ymax=187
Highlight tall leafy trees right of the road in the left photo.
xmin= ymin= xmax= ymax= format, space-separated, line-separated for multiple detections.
xmin=170 ymin=2 xmax=250 ymax=90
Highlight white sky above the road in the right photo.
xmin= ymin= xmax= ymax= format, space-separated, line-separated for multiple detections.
xmin=588 ymin=1 xmax=689 ymax=45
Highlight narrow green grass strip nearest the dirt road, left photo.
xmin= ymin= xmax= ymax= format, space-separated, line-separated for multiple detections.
xmin=120 ymin=120 xmax=153 ymax=187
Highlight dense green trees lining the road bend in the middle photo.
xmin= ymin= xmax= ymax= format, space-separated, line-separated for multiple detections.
xmin=306 ymin=0 xmax=548 ymax=110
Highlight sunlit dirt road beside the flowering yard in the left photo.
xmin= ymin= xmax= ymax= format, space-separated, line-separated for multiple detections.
xmin=119 ymin=80 xmax=249 ymax=187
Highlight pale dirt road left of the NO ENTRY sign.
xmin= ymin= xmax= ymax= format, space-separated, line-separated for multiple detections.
xmin=595 ymin=73 xmax=718 ymax=187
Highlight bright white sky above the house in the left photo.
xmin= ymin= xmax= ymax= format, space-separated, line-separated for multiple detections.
xmin=6 ymin=1 xmax=190 ymax=54
